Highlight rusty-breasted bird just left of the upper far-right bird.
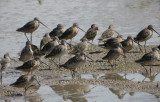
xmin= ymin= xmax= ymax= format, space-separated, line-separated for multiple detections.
xmin=121 ymin=36 xmax=134 ymax=54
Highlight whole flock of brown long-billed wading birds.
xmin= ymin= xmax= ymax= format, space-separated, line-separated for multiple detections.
xmin=0 ymin=17 xmax=160 ymax=93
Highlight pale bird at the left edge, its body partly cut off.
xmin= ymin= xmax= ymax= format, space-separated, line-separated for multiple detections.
xmin=0 ymin=53 xmax=11 ymax=84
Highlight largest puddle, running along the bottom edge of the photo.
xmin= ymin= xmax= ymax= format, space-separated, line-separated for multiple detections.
xmin=0 ymin=84 xmax=160 ymax=102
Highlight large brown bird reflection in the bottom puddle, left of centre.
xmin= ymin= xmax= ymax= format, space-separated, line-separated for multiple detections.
xmin=51 ymin=84 xmax=90 ymax=102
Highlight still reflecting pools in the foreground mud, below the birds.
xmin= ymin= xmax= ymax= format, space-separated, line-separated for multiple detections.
xmin=0 ymin=72 xmax=160 ymax=102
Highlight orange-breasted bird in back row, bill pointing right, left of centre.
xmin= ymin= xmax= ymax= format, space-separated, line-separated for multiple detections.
xmin=59 ymin=23 xmax=83 ymax=41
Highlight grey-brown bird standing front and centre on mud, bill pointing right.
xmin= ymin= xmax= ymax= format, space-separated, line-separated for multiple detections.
xmin=59 ymin=53 xmax=87 ymax=78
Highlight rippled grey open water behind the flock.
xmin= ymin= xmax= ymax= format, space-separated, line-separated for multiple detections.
xmin=0 ymin=0 xmax=160 ymax=57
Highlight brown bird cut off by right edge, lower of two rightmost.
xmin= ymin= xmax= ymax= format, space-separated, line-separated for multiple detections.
xmin=135 ymin=48 xmax=160 ymax=74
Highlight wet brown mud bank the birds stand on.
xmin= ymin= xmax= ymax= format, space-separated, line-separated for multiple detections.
xmin=0 ymin=45 xmax=160 ymax=98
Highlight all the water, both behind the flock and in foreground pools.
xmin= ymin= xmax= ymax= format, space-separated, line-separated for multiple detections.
xmin=0 ymin=0 xmax=160 ymax=102
